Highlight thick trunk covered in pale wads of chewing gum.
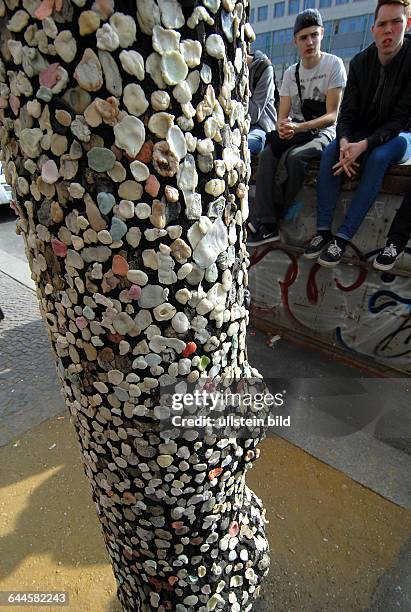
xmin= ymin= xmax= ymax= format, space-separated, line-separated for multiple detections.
xmin=0 ymin=0 xmax=269 ymax=612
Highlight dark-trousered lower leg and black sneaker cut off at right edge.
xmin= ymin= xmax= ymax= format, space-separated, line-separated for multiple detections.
xmin=374 ymin=182 xmax=411 ymax=271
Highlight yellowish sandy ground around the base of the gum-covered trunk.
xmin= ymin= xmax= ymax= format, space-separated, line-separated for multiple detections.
xmin=0 ymin=413 xmax=411 ymax=612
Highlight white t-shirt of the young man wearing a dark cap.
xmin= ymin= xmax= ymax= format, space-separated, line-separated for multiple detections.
xmin=280 ymin=52 xmax=347 ymax=140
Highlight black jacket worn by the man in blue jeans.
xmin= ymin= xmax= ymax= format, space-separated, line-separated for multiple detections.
xmin=337 ymin=34 xmax=411 ymax=149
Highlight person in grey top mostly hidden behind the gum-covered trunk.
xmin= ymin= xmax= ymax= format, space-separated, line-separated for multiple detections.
xmin=247 ymin=51 xmax=278 ymax=155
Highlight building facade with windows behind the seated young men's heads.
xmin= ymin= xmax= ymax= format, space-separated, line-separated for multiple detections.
xmin=250 ymin=0 xmax=376 ymax=78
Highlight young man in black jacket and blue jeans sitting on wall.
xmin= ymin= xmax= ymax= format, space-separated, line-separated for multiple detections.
xmin=305 ymin=0 xmax=411 ymax=267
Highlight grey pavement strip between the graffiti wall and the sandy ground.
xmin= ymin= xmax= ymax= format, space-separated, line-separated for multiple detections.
xmin=247 ymin=330 xmax=411 ymax=510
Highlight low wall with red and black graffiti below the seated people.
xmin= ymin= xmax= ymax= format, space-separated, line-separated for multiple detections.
xmin=250 ymin=246 xmax=411 ymax=373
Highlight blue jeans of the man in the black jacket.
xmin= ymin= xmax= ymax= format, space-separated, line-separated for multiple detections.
xmin=317 ymin=132 xmax=411 ymax=240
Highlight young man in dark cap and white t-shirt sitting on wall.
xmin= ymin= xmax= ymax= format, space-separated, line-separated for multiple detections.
xmin=247 ymin=9 xmax=346 ymax=246
